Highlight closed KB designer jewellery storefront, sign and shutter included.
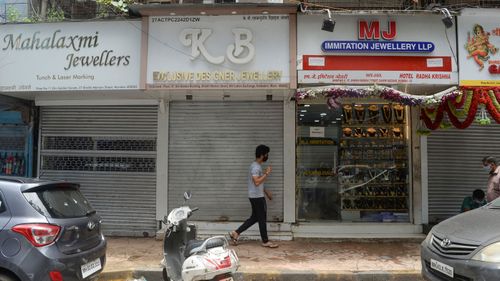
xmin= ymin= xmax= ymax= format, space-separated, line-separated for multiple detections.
xmin=138 ymin=5 xmax=296 ymax=237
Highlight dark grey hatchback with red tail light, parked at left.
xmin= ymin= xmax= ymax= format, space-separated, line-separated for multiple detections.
xmin=0 ymin=177 xmax=106 ymax=281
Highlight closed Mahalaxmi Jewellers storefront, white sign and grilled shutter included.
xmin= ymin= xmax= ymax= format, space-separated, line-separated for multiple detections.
xmin=0 ymin=21 xmax=158 ymax=236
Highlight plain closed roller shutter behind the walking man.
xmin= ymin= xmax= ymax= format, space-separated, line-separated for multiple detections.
xmin=168 ymin=102 xmax=283 ymax=221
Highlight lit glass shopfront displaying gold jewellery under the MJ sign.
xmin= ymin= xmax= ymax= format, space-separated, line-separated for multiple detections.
xmin=296 ymin=99 xmax=410 ymax=222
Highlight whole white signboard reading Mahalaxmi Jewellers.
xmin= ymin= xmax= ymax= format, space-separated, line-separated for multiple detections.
xmin=0 ymin=21 xmax=141 ymax=92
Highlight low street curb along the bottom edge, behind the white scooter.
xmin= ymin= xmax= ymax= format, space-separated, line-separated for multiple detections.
xmin=98 ymin=269 xmax=424 ymax=281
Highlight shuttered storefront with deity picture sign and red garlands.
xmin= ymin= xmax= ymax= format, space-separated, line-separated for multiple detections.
xmin=422 ymin=9 xmax=500 ymax=224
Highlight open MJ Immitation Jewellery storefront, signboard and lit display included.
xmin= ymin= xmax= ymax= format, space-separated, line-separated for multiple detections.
xmin=294 ymin=13 xmax=458 ymax=237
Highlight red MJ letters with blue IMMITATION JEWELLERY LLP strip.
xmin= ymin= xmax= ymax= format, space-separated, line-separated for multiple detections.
xmin=321 ymin=20 xmax=435 ymax=53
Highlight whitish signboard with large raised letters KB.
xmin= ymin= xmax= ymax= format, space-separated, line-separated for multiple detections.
xmin=146 ymin=15 xmax=290 ymax=89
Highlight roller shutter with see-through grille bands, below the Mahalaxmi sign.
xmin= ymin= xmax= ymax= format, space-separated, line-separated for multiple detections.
xmin=40 ymin=106 xmax=158 ymax=236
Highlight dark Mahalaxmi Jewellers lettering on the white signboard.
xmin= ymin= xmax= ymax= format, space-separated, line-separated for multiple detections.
xmin=1 ymin=29 xmax=130 ymax=70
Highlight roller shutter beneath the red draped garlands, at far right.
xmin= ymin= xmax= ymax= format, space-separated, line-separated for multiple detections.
xmin=427 ymin=124 xmax=500 ymax=223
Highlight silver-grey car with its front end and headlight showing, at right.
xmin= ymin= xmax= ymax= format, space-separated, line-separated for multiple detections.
xmin=420 ymin=199 xmax=500 ymax=281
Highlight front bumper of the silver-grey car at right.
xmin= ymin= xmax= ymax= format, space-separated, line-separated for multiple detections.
xmin=420 ymin=242 xmax=500 ymax=281
